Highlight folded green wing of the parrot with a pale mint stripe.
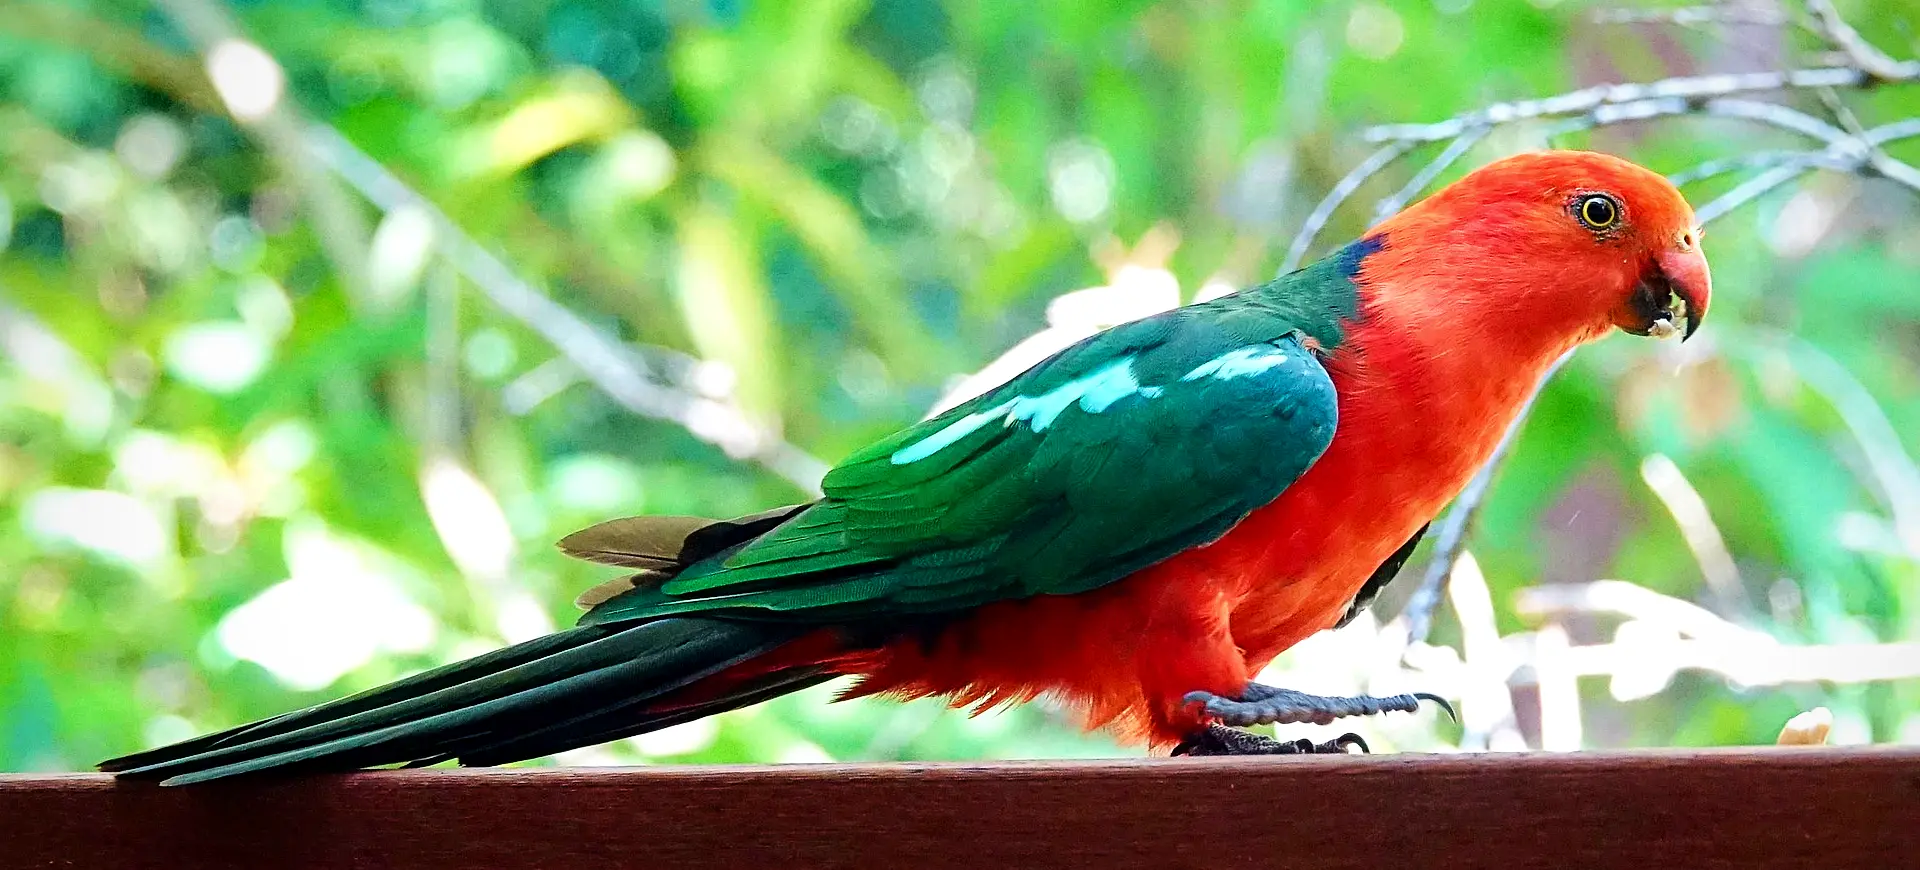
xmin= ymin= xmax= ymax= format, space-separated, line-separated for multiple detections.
xmin=584 ymin=305 xmax=1336 ymax=622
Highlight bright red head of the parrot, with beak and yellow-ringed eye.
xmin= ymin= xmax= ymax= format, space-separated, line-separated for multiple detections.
xmin=1369 ymin=152 xmax=1713 ymax=342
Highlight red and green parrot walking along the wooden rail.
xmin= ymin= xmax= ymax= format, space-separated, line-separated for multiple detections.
xmin=100 ymin=150 xmax=1711 ymax=785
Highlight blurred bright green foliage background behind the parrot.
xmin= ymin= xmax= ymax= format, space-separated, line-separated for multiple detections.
xmin=0 ymin=0 xmax=1920 ymax=770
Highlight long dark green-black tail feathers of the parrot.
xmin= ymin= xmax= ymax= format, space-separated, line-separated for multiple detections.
xmin=100 ymin=618 xmax=835 ymax=785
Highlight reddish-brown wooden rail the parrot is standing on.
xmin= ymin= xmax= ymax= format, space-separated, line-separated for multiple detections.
xmin=0 ymin=747 xmax=1920 ymax=870
